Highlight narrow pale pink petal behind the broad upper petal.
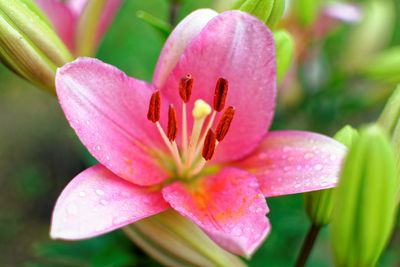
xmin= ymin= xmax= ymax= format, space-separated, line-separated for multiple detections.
xmin=153 ymin=9 xmax=218 ymax=87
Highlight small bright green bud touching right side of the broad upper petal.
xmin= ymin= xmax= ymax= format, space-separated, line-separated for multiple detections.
xmin=274 ymin=30 xmax=294 ymax=83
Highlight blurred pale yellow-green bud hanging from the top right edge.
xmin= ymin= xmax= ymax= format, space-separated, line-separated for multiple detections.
xmin=341 ymin=0 xmax=396 ymax=72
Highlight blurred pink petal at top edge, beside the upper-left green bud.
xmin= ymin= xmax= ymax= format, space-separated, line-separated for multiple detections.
xmin=35 ymin=0 xmax=76 ymax=51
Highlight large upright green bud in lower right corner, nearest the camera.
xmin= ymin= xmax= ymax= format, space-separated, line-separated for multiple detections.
xmin=331 ymin=125 xmax=397 ymax=266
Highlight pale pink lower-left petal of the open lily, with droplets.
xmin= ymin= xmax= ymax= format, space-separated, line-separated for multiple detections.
xmin=50 ymin=164 xmax=169 ymax=240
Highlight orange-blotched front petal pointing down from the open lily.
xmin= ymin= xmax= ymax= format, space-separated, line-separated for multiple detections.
xmin=162 ymin=168 xmax=270 ymax=257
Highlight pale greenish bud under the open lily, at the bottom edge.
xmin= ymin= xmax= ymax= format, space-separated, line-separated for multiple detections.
xmin=124 ymin=210 xmax=246 ymax=267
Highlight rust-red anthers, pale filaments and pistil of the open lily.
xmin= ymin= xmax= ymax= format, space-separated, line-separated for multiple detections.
xmin=147 ymin=75 xmax=235 ymax=178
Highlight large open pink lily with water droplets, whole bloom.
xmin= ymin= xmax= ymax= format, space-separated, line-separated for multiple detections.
xmin=51 ymin=9 xmax=346 ymax=256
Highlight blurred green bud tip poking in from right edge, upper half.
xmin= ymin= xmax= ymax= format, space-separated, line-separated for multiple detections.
xmin=362 ymin=46 xmax=400 ymax=84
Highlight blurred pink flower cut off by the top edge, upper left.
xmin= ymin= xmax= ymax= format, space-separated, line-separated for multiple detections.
xmin=35 ymin=0 xmax=122 ymax=55
